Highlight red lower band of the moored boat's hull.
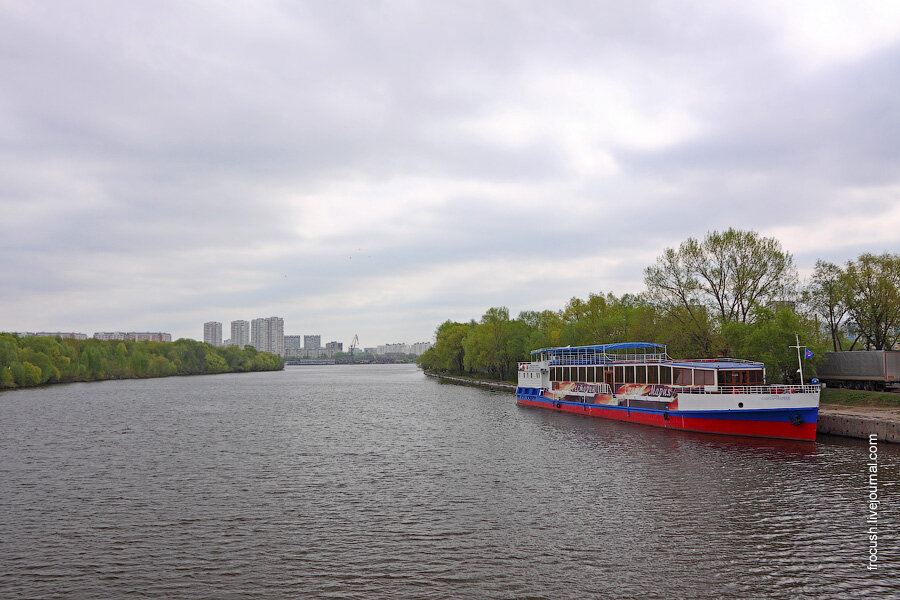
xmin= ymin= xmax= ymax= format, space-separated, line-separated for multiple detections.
xmin=517 ymin=399 xmax=816 ymax=441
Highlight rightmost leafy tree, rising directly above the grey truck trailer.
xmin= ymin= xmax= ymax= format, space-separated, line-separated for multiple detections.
xmin=842 ymin=253 xmax=900 ymax=350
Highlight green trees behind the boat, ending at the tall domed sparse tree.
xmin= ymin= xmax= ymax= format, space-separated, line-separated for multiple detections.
xmin=418 ymin=229 xmax=839 ymax=382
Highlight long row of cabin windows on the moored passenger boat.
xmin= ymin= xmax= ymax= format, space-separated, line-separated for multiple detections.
xmin=550 ymin=365 xmax=763 ymax=386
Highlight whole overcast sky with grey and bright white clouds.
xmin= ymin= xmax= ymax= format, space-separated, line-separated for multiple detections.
xmin=0 ymin=0 xmax=900 ymax=346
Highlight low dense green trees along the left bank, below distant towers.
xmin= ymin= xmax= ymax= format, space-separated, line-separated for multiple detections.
xmin=0 ymin=333 xmax=284 ymax=390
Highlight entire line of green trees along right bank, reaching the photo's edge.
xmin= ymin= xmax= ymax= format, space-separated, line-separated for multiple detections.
xmin=418 ymin=229 xmax=900 ymax=383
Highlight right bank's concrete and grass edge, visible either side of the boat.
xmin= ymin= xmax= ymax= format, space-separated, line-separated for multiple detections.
xmin=425 ymin=371 xmax=900 ymax=444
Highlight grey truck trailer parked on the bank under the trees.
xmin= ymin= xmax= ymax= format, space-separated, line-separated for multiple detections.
xmin=816 ymin=350 xmax=900 ymax=391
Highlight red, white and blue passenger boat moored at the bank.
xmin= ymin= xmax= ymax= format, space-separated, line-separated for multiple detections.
xmin=516 ymin=342 xmax=820 ymax=440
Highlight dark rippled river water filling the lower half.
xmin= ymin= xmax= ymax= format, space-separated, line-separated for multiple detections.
xmin=0 ymin=365 xmax=900 ymax=599
